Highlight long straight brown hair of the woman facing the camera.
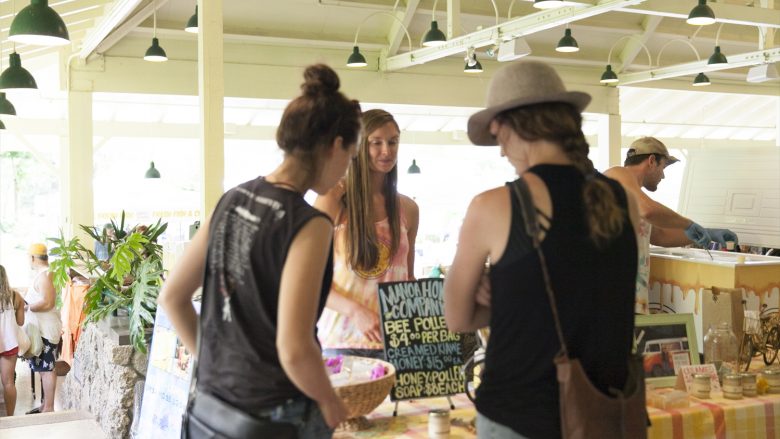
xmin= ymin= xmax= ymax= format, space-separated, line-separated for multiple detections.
xmin=342 ymin=110 xmax=401 ymax=270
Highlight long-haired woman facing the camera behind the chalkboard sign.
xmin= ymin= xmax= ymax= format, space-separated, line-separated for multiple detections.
xmin=314 ymin=110 xmax=419 ymax=358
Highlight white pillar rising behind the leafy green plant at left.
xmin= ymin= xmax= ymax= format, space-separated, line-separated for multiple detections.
xmin=60 ymin=91 xmax=95 ymax=242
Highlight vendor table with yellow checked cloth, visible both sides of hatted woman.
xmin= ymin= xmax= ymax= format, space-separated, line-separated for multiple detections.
xmin=334 ymin=395 xmax=780 ymax=439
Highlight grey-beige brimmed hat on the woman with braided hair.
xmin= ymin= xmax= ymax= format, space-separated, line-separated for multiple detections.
xmin=468 ymin=60 xmax=590 ymax=146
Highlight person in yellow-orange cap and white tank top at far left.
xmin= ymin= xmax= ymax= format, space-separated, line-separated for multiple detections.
xmin=24 ymin=243 xmax=62 ymax=414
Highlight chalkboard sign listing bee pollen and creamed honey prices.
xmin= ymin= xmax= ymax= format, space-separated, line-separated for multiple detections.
xmin=379 ymin=279 xmax=465 ymax=401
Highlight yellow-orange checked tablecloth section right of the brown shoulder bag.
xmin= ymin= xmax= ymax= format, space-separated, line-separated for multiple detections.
xmin=648 ymin=395 xmax=780 ymax=439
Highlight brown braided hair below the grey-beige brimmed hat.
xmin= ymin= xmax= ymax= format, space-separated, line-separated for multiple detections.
xmin=496 ymin=102 xmax=626 ymax=248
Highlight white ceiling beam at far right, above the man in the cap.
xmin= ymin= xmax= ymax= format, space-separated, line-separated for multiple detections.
xmin=618 ymin=48 xmax=780 ymax=85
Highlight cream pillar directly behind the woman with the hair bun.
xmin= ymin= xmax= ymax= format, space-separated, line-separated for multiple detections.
xmin=198 ymin=0 xmax=225 ymax=219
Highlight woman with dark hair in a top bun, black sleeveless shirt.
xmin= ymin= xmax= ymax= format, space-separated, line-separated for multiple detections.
xmin=159 ymin=65 xmax=360 ymax=439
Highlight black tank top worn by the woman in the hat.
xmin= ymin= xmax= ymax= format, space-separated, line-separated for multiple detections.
xmin=477 ymin=165 xmax=637 ymax=438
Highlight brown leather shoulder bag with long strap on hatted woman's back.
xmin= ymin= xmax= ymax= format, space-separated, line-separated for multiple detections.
xmin=512 ymin=177 xmax=648 ymax=439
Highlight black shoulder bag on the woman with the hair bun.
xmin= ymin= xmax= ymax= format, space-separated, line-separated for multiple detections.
xmin=181 ymin=328 xmax=298 ymax=439
